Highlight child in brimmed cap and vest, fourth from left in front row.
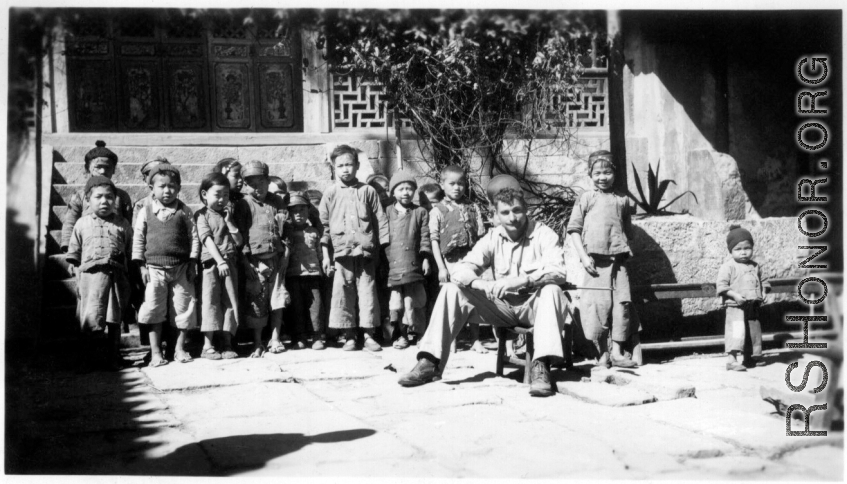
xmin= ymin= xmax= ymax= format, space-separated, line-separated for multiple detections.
xmin=235 ymin=160 xmax=289 ymax=358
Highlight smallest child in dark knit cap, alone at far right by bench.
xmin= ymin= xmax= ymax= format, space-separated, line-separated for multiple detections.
xmin=715 ymin=225 xmax=771 ymax=371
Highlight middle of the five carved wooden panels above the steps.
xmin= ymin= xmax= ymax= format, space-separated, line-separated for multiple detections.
xmin=165 ymin=61 xmax=209 ymax=130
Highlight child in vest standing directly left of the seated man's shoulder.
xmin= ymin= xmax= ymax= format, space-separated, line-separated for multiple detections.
xmin=429 ymin=165 xmax=488 ymax=353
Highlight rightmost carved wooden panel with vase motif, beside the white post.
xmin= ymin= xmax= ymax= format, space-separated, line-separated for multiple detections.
xmin=257 ymin=64 xmax=298 ymax=128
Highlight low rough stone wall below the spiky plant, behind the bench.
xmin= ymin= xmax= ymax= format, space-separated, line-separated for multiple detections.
xmin=565 ymin=215 xmax=809 ymax=340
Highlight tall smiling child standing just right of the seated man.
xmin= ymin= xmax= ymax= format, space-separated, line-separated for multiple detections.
xmin=567 ymin=150 xmax=638 ymax=368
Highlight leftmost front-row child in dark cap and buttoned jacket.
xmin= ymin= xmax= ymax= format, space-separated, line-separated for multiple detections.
xmin=67 ymin=175 xmax=132 ymax=368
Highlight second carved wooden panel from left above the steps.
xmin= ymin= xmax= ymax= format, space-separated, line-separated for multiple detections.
xmin=118 ymin=61 xmax=162 ymax=131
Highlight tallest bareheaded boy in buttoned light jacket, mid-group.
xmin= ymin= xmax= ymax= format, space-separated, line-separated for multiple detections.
xmin=320 ymin=145 xmax=388 ymax=351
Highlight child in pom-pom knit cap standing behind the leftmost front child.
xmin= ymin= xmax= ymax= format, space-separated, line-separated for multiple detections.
xmin=60 ymin=140 xmax=132 ymax=252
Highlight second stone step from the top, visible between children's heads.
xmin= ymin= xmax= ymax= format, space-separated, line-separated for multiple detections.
xmin=53 ymin=161 xmax=332 ymax=185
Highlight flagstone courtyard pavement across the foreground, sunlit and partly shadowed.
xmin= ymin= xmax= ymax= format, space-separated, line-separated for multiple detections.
xmin=6 ymin=342 xmax=844 ymax=480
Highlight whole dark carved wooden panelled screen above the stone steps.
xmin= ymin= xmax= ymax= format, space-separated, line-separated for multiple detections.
xmin=66 ymin=9 xmax=303 ymax=132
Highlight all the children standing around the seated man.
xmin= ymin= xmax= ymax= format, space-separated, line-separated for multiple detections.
xmin=62 ymin=141 xmax=767 ymax=371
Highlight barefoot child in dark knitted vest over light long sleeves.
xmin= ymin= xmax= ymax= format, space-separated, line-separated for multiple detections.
xmin=132 ymin=164 xmax=200 ymax=367
